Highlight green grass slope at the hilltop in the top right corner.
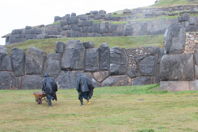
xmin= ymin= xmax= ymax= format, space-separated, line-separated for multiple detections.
xmin=153 ymin=0 xmax=198 ymax=7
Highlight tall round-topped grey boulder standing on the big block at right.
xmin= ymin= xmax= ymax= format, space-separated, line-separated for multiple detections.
xmin=164 ymin=24 xmax=186 ymax=54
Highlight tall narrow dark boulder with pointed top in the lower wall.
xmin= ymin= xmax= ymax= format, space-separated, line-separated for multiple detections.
xmin=98 ymin=43 xmax=110 ymax=70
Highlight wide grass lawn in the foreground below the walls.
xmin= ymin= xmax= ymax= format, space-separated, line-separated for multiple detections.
xmin=0 ymin=85 xmax=198 ymax=132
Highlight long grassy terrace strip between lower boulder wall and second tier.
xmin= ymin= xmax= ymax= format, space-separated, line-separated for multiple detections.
xmin=7 ymin=35 xmax=163 ymax=53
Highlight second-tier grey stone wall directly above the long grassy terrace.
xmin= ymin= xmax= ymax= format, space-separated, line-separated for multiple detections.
xmin=3 ymin=16 xmax=177 ymax=44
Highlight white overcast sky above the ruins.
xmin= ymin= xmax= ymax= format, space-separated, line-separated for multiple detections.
xmin=0 ymin=0 xmax=155 ymax=45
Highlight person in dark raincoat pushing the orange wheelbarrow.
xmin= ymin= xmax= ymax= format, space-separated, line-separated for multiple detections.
xmin=42 ymin=74 xmax=58 ymax=106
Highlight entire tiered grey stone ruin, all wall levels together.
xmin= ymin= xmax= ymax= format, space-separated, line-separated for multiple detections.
xmin=0 ymin=5 xmax=198 ymax=91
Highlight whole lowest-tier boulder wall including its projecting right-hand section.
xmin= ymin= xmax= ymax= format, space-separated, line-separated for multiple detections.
xmin=0 ymin=21 xmax=198 ymax=91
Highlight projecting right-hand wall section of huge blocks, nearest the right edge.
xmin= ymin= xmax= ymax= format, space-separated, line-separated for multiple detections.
xmin=160 ymin=23 xmax=198 ymax=91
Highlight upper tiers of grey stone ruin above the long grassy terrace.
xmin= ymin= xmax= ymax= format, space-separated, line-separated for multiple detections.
xmin=3 ymin=5 xmax=198 ymax=44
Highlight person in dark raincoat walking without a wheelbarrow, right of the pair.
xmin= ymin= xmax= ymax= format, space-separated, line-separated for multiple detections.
xmin=76 ymin=75 xmax=94 ymax=105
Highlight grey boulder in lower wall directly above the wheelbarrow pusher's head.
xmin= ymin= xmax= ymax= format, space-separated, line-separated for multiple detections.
xmin=44 ymin=53 xmax=61 ymax=77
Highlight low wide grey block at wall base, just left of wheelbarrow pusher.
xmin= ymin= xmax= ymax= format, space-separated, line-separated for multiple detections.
xmin=21 ymin=75 xmax=43 ymax=89
